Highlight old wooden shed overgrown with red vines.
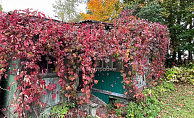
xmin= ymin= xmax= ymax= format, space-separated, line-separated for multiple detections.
xmin=0 ymin=10 xmax=169 ymax=117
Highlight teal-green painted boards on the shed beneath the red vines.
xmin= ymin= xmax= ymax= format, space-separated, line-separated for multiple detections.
xmin=92 ymin=71 xmax=125 ymax=103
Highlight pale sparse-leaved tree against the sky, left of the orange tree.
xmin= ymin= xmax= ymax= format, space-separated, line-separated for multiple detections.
xmin=53 ymin=0 xmax=80 ymax=22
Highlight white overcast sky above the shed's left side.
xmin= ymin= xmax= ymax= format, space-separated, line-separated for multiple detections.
xmin=0 ymin=0 xmax=86 ymax=18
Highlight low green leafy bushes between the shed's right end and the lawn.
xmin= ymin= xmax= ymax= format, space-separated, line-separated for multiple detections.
xmin=126 ymin=82 xmax=175 ymax=118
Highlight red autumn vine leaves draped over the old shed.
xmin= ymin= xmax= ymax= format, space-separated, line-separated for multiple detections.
xmin=0 ymin=10 xmax=169 ymax=117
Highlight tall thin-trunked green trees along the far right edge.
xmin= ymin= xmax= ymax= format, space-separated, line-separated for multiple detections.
xmin=161 ymin=0 xmax=194 ymax=64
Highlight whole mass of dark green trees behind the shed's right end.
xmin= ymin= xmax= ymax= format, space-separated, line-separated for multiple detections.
xmin=126 ymin=0 xmax=194 ymax=66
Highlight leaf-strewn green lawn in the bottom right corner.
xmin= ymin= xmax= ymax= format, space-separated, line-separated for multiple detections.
xmin=158 ymin=84 xmax=194 ymax=118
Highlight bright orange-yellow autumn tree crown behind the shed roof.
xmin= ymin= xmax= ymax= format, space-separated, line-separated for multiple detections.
xmin=81 ymin=0 xmax=124 ymax=22
